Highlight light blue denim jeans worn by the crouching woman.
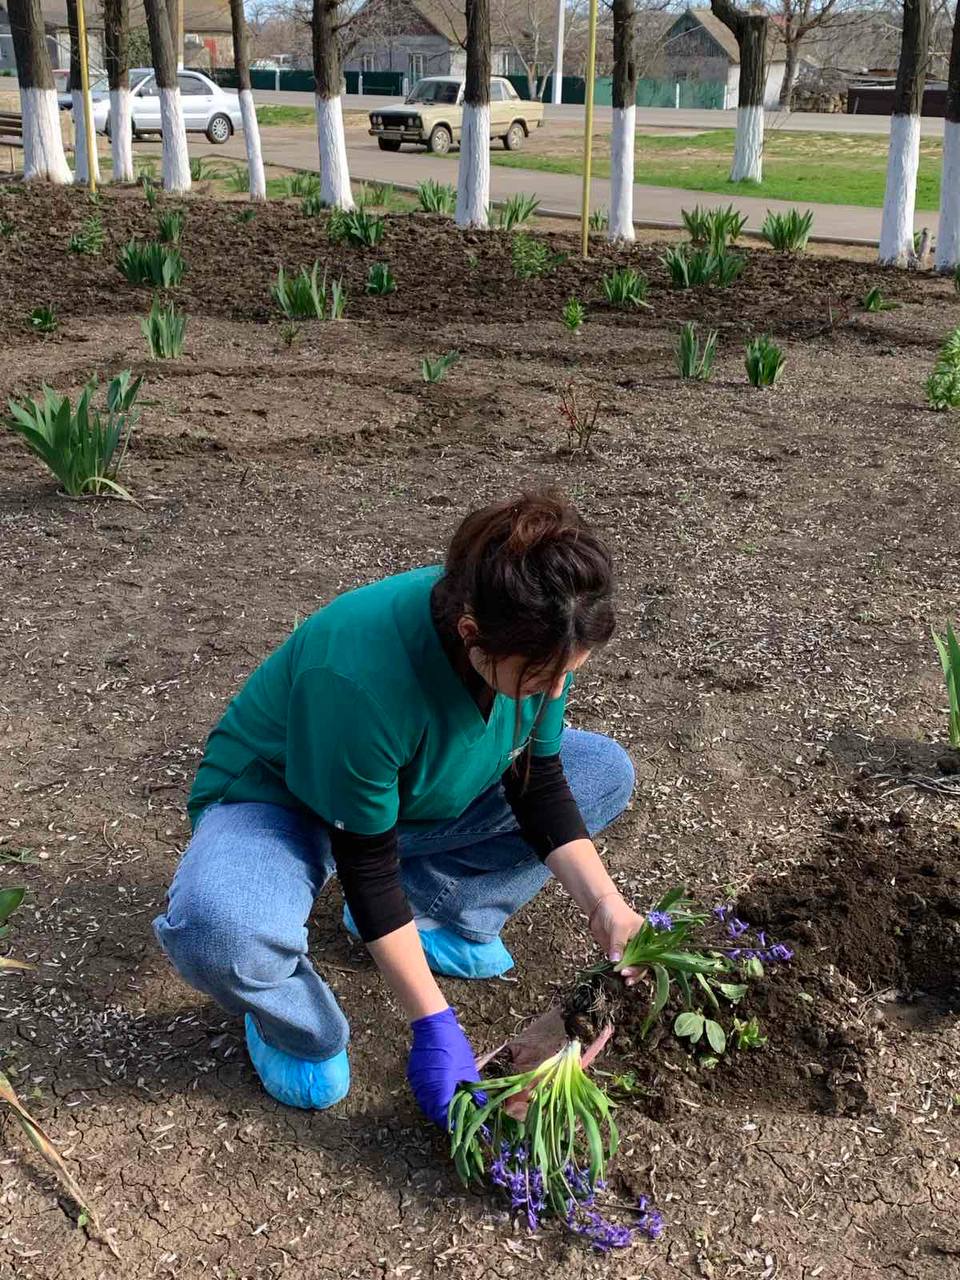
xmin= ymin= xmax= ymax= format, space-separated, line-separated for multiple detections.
xmin=154 ymin=730 xmax=634 ymax=1061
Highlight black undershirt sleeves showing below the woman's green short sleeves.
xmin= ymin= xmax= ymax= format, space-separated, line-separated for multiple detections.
xmin=330 ymin=755 xmax=588 ymax=942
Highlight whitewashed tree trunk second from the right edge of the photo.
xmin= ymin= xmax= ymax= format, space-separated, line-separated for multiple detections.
xmin=878 ymin=0 xmax=931 ymax=266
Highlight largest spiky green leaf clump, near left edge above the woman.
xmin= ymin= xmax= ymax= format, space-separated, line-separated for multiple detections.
xmin=8 ymin=369 xmax=143 ymax=499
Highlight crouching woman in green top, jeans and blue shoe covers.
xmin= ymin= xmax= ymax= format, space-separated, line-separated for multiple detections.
xmin=154 ymin=494 xmax=640 ymax=1126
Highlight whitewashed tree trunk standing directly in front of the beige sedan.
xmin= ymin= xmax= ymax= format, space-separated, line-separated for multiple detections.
xmin=456 ymin=0 xmax=490 ymax=227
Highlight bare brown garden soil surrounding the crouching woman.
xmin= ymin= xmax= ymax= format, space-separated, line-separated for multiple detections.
xmin=0 ymin=183 xmax=960 ymax=1280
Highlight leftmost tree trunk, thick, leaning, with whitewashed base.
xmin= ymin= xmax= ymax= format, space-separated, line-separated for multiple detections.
xmin=8 ymin=0 xmax=73 ymax=186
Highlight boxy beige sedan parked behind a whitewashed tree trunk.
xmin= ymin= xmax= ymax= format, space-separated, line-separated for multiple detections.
xmin=370 ymin=76 xmax=543 ymax=156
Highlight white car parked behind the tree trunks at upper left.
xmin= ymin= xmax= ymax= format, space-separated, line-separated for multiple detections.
xmin=60 ymin=67 xmax=243 ymax=142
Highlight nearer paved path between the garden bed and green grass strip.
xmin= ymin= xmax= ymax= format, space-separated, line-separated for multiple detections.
xmin=188 ymin=127 xmax=937 ymax=244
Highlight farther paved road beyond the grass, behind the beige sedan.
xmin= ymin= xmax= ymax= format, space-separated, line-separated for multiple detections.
xmin=253 ymin=90 xmax=943 ymax=138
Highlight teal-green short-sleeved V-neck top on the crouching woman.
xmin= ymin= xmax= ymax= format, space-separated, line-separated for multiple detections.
xmin=187 ymin=567 xmax=566 ymax=836
